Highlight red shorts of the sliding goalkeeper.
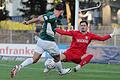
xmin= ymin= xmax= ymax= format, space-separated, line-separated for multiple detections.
xmin=64 ymin=49 xmax=83 ymax=64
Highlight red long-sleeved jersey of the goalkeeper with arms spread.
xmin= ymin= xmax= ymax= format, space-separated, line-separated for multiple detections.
xmin=56 ymin=28 xmax=111 ymax=54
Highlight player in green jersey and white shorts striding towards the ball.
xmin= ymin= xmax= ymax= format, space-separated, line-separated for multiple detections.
xmin=11 ymin=4 xmax=71 ymax=78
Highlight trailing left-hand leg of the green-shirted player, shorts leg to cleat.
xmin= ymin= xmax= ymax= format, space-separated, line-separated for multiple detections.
xmin=10 ymin=40 xmax=44 ymax=78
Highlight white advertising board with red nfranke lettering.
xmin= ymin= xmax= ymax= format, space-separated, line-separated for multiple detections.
xmin=0 ymin=44 xmax=35 ymax=57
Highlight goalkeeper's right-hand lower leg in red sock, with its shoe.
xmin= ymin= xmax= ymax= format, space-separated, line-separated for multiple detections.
xmin=74 ymin=54 xmax=93 ymax=72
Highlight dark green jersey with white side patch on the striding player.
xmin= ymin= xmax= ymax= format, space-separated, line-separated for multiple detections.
xmin=39 ymin=12 xmax=57 ymax=41
